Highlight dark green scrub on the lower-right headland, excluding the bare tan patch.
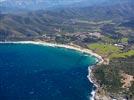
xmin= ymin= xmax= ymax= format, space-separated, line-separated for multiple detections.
xmin=93 ymin=56 xmax=134 ymax=100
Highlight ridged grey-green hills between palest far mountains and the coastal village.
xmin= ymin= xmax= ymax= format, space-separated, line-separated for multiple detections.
xmin=0 ymin=2 xmax=134 ymax=40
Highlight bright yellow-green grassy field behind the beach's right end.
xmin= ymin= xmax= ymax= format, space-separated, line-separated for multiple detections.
xmin=88 ymin=43 xmax=134 ymax=59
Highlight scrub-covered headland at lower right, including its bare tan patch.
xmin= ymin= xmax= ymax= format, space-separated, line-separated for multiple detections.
xmin=94 ymin=56 xmax=134 ymax=100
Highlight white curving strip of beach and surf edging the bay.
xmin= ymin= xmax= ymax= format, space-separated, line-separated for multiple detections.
xmin=0 ymin=41 xmax=104 ymax=100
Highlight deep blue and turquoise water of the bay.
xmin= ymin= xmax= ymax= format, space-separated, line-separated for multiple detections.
xmin=0 ymin=44 xmax=96 ymax=100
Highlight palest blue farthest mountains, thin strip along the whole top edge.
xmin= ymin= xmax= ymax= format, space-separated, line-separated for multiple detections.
xmin=0 ymin=0 xmax=134 ymax=10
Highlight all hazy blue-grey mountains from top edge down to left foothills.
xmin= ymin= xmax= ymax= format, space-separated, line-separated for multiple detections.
xmin=0 ymin=0 xmax=134 ymax=39
